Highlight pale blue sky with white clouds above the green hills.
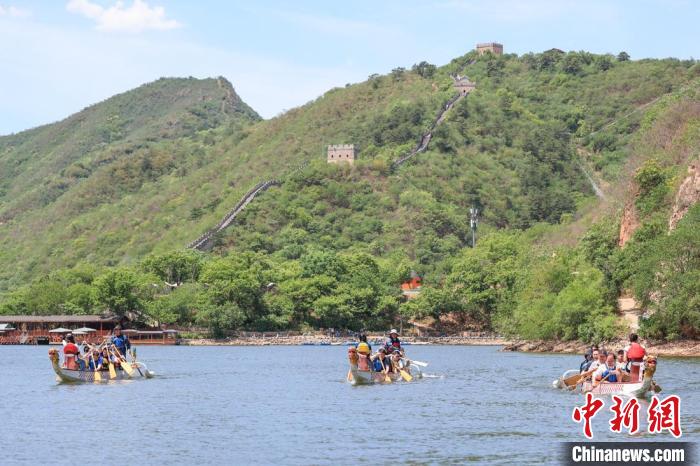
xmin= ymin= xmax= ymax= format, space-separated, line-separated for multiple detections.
xmin=0 ymin=0 xmax=700 ymax=135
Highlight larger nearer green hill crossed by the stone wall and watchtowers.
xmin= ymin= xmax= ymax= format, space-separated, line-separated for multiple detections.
xmin=0 ymin=51 xmax=700 ymax=339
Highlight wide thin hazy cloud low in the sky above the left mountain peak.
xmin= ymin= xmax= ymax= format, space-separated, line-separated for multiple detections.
xmin=0 ymin=17 xmax=369 ymax=135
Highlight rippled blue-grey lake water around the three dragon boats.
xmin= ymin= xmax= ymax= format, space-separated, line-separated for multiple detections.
xmin=0 ymin=346 xmax=700 ymax=465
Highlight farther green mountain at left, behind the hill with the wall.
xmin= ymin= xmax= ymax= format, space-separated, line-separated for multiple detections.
xmin=0 ymin=78 xmax=260 ymax=288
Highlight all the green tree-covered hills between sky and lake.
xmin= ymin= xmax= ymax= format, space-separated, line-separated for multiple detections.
xmin=0 ymin=50 xmax=700 ymax=339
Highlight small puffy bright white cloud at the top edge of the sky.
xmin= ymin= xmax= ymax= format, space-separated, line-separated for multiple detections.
xmin=66 ymin=0 xmax=181 ymax=32
